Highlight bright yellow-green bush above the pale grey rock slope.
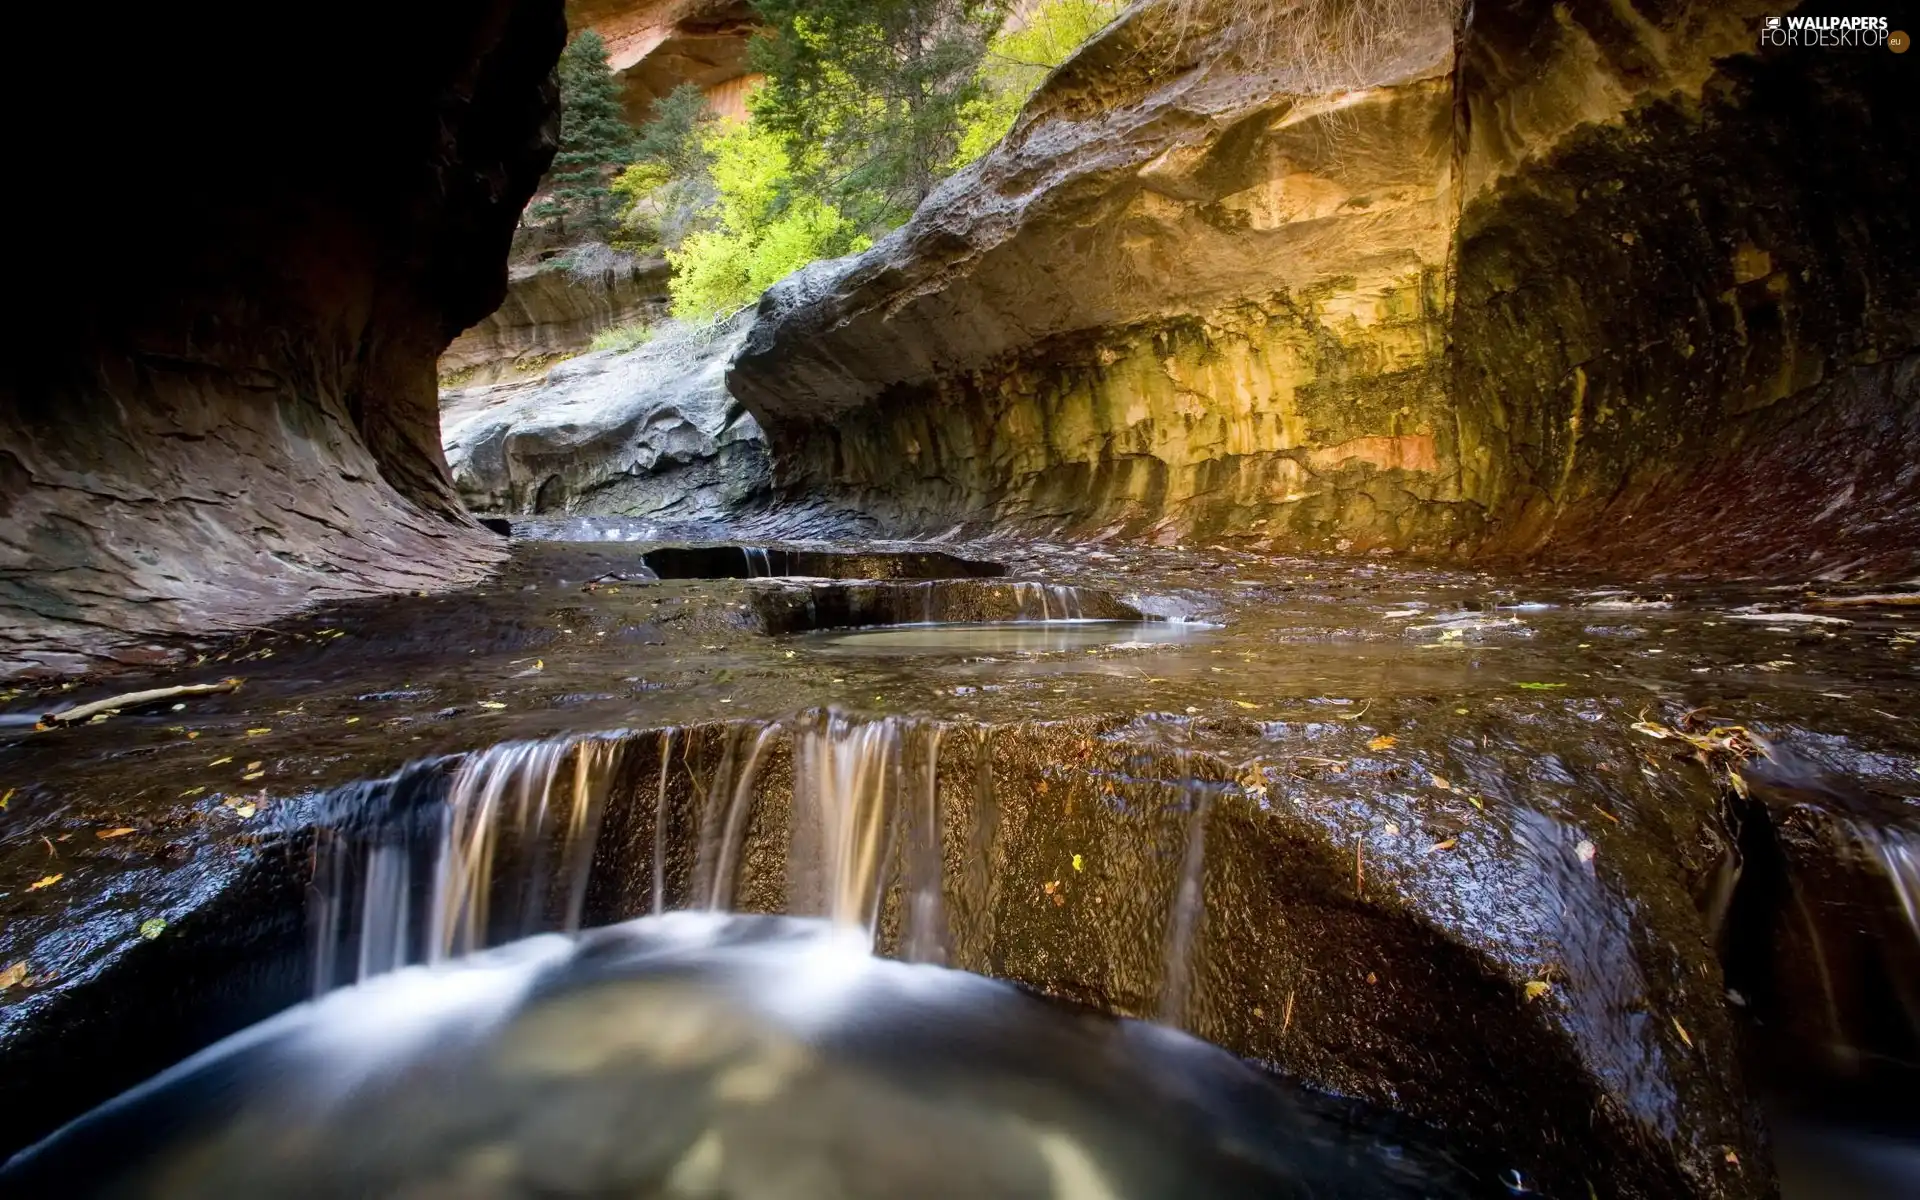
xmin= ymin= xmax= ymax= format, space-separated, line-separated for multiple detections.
xmin=666 ymin=121 xmax=872 ymax=321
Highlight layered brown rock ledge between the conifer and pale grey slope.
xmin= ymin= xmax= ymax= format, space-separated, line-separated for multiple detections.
xmin=440 ymin=246 xmax=670 ymax=382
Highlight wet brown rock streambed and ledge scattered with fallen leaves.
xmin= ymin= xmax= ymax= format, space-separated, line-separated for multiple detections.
xmin=0 ymin=529 xmax=1920 ymax=1196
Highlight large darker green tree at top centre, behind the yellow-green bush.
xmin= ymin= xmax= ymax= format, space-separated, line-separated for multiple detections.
xmin=749 ymin=0 xmax=1010 ymax=230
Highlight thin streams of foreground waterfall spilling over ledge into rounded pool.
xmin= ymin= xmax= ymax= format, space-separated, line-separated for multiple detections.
xmin=313 ymin=710 xmax=1221 ymax=1021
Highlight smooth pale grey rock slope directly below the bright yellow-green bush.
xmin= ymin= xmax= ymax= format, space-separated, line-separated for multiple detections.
xmin=442 ymin=313 xmax=770 ymax=520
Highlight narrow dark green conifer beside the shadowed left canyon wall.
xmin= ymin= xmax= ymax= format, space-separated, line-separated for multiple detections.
xmin=530 ymin=29 xmax=634 ymax=238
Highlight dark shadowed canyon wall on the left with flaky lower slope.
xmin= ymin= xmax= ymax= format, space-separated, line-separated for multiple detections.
xmin=0 ymin=0 xmax=564 ymax=678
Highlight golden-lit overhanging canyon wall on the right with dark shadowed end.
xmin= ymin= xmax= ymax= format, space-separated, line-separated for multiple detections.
xmin=730 ymin=0 xmax=1920 ymax=576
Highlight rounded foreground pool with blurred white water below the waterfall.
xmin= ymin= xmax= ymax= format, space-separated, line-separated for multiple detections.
xmin=0 ymin=914 xmax=1496 ymax=1200
